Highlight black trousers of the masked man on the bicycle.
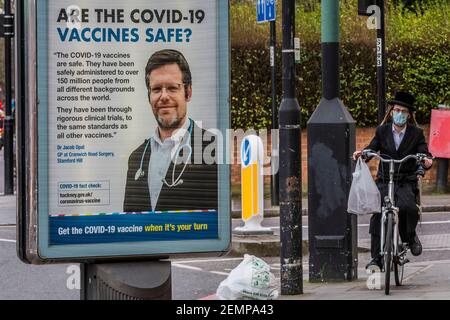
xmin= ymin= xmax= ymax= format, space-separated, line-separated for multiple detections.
xmin=369 ymin=181 xmax=419 ymax=258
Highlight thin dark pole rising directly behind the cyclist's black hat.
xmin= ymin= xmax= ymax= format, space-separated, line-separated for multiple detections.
xmin=377 ymin=0 xmax=387 ymax=124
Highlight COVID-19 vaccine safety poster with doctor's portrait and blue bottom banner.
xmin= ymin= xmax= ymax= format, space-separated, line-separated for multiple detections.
xmin=37 ymin=0 xmax=230 ymax=256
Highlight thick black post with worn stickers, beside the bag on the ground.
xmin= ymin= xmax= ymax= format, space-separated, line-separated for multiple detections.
xmin=279 ymin=0 xmax=303 ymax=295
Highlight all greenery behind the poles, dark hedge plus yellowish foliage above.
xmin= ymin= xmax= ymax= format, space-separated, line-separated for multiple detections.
xmin=230 ymin=0 xmax=450 ymax=129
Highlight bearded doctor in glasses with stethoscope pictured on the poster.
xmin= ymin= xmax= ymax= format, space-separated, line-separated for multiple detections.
xmin=123 ymin=49 xmax=218 ymax=213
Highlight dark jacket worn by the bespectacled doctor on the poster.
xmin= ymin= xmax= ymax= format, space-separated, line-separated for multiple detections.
xmin=123 ymin=124 xmax=218 ymax=212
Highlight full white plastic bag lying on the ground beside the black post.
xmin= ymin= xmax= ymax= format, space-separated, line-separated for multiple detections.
xmin=216 ymin=254 xmax=278 ymax=300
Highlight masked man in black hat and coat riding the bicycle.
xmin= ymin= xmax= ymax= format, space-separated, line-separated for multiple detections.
xmin=353 ymin=91 xmax=433 ymax=270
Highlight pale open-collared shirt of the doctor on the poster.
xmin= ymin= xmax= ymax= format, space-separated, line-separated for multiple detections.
xmin=147 ymin=118 xmax=191 ymax=211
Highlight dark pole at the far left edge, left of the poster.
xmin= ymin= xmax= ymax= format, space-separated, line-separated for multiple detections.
xmin=4 ymin=0 xmax=14 ymax=195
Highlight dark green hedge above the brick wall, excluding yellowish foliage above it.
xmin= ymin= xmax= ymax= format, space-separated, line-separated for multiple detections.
xmin=231 ymin=42 xmax=450 ymax=129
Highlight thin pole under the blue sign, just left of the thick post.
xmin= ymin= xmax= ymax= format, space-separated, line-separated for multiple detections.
xmin=270 ymin=21 xmax=280 ymax=206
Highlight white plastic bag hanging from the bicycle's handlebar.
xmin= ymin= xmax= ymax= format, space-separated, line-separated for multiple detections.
xmin=347 ymin=157 xmax=381 ymax=214
